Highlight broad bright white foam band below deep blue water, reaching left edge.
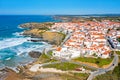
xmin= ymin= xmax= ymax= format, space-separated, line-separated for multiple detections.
xmin=0 ymin=38 xmax=27 ymax=49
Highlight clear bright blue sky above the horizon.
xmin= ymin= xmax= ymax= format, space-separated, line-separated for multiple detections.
xmin=0 ymin=0 xmax=120 ymax=15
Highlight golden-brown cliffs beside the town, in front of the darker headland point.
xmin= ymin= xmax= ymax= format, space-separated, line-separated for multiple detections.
xmin=23 ymin=29 xmax=65 ymax=45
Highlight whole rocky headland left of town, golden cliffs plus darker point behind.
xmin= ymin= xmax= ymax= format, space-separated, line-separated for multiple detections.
xmin=20 ymin=22 xmax=65 ymax=45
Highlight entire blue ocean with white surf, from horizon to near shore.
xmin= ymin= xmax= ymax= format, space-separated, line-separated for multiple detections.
xmin=0 ymin=15 xmax=56 ymax=69
